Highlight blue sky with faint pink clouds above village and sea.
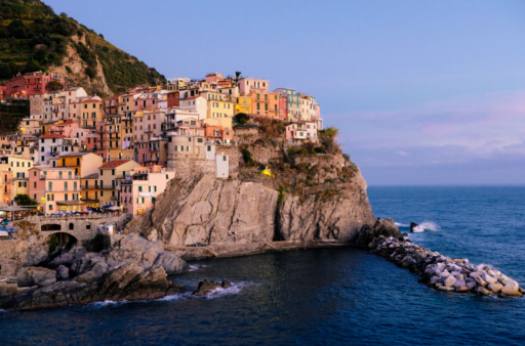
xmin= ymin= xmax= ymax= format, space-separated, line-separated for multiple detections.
xmin=45 ymin=0 xmax=525 ymax=185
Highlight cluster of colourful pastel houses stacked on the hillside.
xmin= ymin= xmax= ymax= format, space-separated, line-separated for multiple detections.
xmin=0 ymin=72 xmax=322 ymax=215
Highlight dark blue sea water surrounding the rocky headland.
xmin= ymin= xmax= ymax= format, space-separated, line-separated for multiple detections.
xmin=0 ymin=187 xmax=525 ymax=345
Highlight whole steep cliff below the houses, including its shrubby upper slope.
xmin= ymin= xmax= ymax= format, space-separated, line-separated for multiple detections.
xmin=128 ymin=122 xmax=375 ymax=258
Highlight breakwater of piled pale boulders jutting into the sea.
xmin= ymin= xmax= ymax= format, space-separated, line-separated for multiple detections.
xmin=357 ymin=219 xmax=524 ymax=297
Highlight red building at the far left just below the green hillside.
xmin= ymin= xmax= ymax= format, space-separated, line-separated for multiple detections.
xmin=4 ymin=71 xmax=64 ymax=98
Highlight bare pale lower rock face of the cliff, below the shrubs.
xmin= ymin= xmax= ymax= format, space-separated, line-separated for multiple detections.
xmin=129 ymin=164 xmax=374 ymax=257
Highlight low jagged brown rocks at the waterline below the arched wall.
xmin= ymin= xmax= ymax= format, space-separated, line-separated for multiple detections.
xmin=0 ymin=234 xmax=186 ymax=309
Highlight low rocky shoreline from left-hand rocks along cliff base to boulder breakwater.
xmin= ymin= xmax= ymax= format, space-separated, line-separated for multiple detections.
xmin=0 ymin=219 xmax=524 ymax=310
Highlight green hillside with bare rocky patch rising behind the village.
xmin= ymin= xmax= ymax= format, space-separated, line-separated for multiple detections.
xmin=0 ymin=0 xmax=166 ymax=96
